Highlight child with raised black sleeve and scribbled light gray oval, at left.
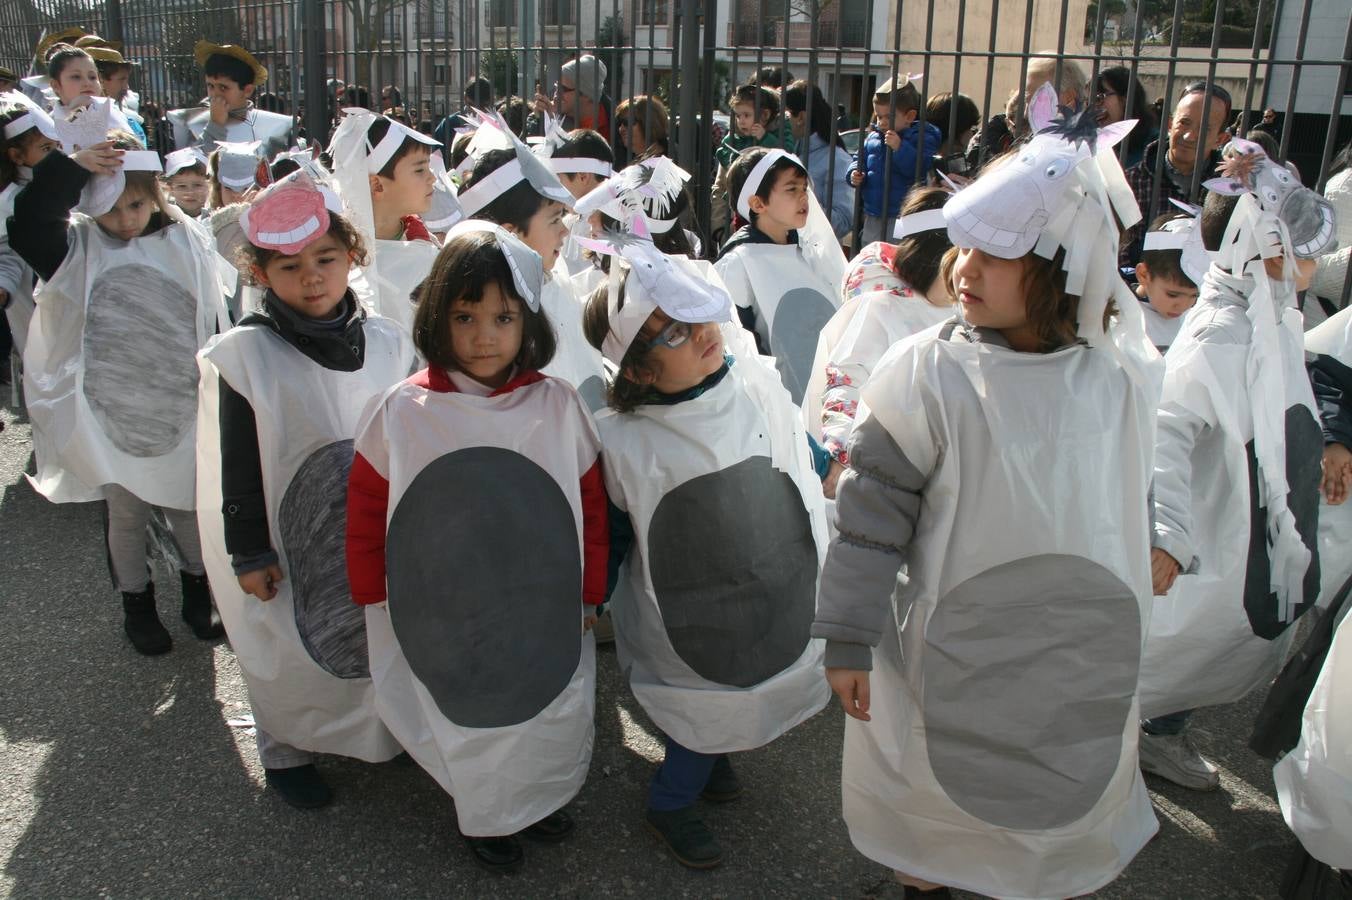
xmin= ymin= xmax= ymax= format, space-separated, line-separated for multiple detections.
xmin=9 ymin=132 xmax=224 ymax=654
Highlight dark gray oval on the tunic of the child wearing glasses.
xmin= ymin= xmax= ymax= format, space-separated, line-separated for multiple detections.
xmin=648 ymin=457 xmax=817 ymax=688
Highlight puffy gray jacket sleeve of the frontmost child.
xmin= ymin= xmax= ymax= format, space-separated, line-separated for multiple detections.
xmin=813 ymin=416 xmax=929 ymax=669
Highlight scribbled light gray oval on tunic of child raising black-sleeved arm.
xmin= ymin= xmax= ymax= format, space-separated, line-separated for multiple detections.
xmin=84 ymin=265 xmax=197 ymax=457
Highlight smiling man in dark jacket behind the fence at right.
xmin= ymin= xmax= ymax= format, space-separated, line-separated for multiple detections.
xmin=1117 ymin=81 xmax=1230 ymax=269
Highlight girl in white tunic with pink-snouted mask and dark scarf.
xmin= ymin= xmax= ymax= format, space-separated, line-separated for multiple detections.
xmin=197 ymin=172 xmax=412 ymax=808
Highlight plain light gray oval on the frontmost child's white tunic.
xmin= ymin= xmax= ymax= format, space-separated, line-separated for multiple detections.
xmin=925 ymin=554 xmax=1141 ymax=831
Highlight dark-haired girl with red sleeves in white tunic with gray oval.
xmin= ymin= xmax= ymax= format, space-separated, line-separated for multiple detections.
xmin=347 ymin=220 xmax=608 ymax=872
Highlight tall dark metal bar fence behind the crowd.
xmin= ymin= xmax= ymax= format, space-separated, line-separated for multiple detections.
xmin=0 ymin=0 xmax=1352 ymax=304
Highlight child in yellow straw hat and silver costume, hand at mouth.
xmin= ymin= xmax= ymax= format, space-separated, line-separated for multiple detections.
xmin=166 ymin=41 xmax=295 ymax=159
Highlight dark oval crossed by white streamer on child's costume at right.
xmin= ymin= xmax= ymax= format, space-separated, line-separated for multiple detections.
xmin=1244 ymin=405 xmax=1324 ymax=641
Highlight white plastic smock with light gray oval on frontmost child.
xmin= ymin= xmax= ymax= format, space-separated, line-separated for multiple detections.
xmin=842 ymin=326 xmax=1157 ymax=897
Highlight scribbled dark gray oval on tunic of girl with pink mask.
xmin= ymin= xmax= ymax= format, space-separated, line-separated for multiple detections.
xmin=277 ymin=441 xmax=370 ymax=678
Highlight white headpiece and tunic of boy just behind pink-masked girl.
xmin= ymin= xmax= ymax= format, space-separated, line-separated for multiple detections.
xmin=330 ymin=109 xmax=441 ymax=334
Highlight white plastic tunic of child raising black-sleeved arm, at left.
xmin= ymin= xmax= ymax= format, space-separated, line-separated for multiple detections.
xmin=23 ymin=193 xmax=226 ymax=509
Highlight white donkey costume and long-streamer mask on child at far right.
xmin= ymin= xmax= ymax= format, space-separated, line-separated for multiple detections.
xmin=1141 ymin=142 xmax=1333 ymax=716
